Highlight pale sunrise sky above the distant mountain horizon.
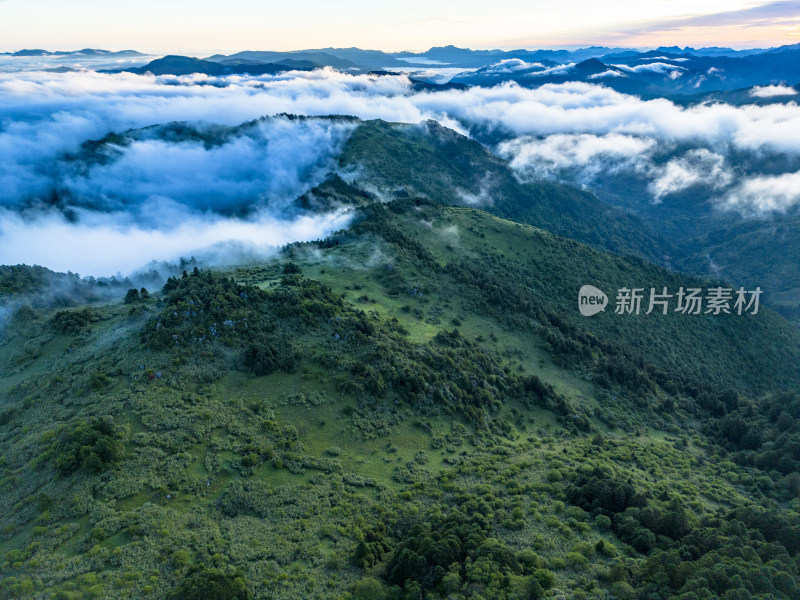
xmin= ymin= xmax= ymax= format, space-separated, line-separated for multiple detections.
xmin=0 ymin=0 xmax=800 ymax=55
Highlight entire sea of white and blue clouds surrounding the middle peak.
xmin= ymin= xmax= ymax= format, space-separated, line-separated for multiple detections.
xmin=0 ymin=70 xmax=800 ymax=275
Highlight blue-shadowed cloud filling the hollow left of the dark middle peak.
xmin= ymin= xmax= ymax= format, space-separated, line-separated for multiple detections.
xmin=63 ymin=118 xmax=355 ymax=213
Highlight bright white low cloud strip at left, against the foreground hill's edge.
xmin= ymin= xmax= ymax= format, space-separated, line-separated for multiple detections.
xmin=0 ymin=205 xmax=351 ymax=276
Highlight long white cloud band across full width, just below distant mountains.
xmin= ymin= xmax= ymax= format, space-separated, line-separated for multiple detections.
xmin=6 ymin=65 xmax=800 ymax=157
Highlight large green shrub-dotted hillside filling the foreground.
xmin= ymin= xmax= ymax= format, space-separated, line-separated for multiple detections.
xmin=0 ymin=204 xmax=800 ymax=600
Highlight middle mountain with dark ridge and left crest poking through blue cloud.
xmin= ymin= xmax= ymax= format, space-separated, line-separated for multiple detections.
xmin=67 ymin=116 xmax=675 ymax=265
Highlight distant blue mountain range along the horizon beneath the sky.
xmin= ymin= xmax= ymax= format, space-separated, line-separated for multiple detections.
xmin=6 ymin=44 xmax=800 ymax=96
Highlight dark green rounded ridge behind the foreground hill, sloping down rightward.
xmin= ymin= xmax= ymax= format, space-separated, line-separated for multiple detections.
xmin=339 ymin=120 xmax=673 ymax=264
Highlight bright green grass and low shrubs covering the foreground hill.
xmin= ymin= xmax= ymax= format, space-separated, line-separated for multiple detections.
xmin=0 ymin=204 xmax=797 ymax=599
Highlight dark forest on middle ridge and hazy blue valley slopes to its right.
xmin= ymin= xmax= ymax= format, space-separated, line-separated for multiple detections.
xmin=340 ymin=117 xmax=800 ymax=323
